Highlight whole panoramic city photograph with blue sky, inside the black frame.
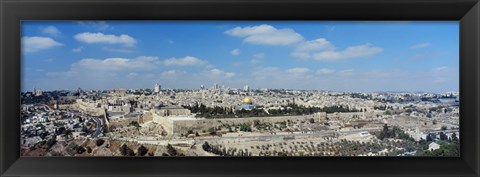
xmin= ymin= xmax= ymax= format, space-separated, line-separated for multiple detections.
xmin=19 ymin=21 xmax=460 ymax=157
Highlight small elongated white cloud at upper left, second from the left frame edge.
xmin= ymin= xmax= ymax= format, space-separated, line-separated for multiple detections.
xmin=74 ymin=32 xmax=137 ymax=47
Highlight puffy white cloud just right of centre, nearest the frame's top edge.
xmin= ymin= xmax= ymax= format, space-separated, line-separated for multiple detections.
xmin=225 ymin=24 xmax=303 ymax=45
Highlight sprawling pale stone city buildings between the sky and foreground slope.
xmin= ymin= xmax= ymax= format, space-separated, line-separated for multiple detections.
xmin=22 ymin=83 xmax=459 ymax=156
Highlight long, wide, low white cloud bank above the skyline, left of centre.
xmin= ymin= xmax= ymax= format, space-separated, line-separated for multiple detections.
xmin=46 ymin=56 xmax=212 ymax=83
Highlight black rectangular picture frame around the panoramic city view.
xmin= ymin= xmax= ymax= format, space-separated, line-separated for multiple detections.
xmin=0 ymin=0 xmax=480 ymax=176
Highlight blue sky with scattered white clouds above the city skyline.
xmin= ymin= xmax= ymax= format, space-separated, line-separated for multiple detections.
xmin=22 ymin=21 xmax=459 ymax=92
